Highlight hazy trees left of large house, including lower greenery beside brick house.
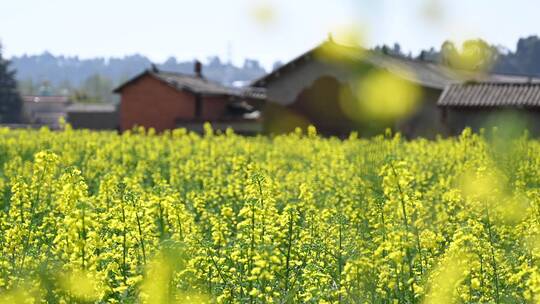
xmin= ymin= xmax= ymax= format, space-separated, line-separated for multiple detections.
xmin=11 ymin=52 xmax=266 ymax=102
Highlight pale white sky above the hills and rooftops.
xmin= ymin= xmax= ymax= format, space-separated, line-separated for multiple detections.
xmin=0 ymin=0 xmax=540 ymax=67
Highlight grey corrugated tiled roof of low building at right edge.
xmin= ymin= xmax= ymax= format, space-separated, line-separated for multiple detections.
xmin=437 ymin=82 xmax=540 ymax=107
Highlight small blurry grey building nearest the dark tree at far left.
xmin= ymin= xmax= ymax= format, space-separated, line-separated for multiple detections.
xmin=22 ymin=95 xmax=69 ymax=129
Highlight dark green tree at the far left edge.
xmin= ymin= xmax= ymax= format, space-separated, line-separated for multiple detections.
xmin=0 ymin=45 xmax=22 ymax=123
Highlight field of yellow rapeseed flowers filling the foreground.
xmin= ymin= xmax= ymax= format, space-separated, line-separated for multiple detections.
xmin=0 ymin=126 xmax=540 ymax=303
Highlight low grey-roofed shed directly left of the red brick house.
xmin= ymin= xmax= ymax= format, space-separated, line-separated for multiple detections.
xmin=66 ymin=103 xmax=119 ymax=130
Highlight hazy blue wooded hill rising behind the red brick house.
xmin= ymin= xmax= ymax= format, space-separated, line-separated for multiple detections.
xmin=11 ymin=52 xmax=266 ymax=87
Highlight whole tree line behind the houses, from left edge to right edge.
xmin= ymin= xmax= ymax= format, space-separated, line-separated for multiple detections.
xmin=0 ymin=36 xmax=540 ymax=123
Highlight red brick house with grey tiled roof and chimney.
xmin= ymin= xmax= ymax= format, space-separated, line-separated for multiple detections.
xmin=114 ymin=62 xmax=265 ymax=133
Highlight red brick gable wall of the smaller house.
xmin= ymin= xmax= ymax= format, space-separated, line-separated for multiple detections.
xmin=120 ymin=75 xmax=196 ymax=132
